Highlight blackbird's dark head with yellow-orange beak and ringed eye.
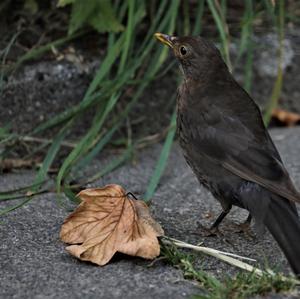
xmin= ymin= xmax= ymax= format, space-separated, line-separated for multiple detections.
xmin=155 ymin=33 xmax=227 ymax=80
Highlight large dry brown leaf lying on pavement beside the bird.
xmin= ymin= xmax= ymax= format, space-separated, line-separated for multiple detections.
xmin=60 ymin=185 xmax=164 ymax=266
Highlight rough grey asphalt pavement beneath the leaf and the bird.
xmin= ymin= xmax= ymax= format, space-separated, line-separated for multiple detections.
xmin=0 ymin=128 xmax=300 ymax=299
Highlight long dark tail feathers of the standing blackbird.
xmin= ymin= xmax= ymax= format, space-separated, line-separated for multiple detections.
xmin=264 ymin=194 xmax=300 ymax=276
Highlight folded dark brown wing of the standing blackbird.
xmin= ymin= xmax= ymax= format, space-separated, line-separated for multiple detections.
xmin=182 ymin=86 xmax=300 ymax=202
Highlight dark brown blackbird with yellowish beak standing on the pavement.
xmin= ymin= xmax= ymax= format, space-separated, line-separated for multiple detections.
xmin=155 ymin=33 xmax=300 ymax=275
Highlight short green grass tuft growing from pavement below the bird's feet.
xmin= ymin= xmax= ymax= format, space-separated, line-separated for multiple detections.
xmin=161 ymin=244 xmax=296 ymax=299
